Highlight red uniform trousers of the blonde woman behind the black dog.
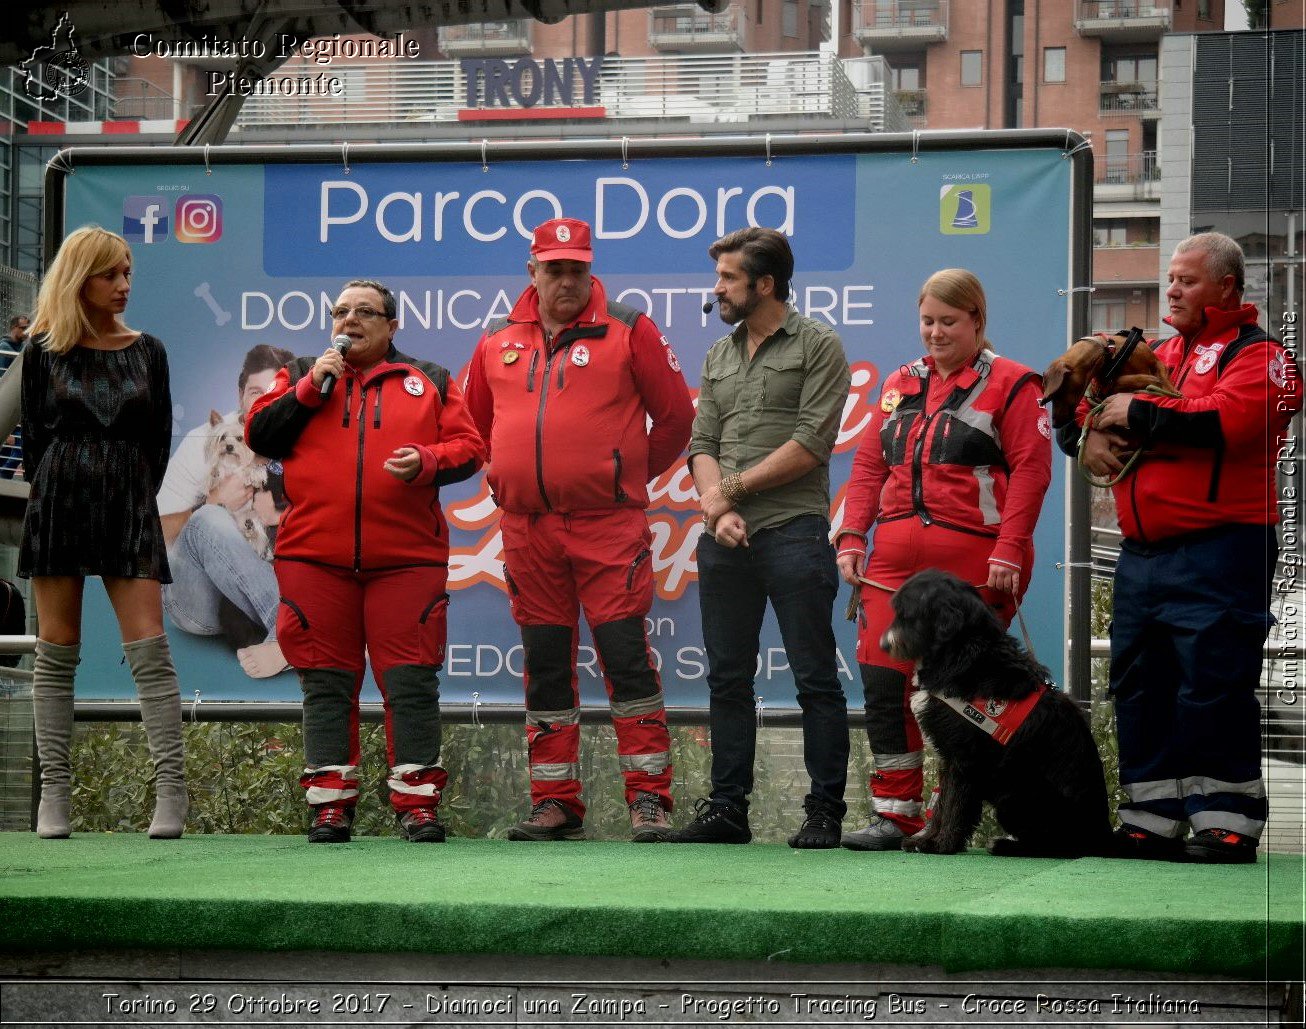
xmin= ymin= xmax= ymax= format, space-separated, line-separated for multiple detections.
xmin=857 ymin=517 xmax=1034 ymax=836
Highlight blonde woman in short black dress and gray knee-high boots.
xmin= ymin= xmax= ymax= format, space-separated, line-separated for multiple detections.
xmin=18 ymin=226 xmax=187 ymax=840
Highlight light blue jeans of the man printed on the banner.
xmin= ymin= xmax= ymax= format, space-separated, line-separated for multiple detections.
xmin=163 ymin=504 xmax=279 ymax=639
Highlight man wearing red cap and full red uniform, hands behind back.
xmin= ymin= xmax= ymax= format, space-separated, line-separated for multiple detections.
xmin=466 ymin=218 xmax=693 ymax=842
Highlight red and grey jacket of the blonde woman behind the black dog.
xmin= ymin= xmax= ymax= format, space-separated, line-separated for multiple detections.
xmin=840 ymin=350 xmax=1053 ymax=568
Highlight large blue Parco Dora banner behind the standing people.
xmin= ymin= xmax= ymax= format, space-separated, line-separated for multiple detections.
xmin=56 ymin=133 xmax=1075 ymax=708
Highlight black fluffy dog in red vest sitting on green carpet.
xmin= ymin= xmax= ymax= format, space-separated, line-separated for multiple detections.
xmin=880 ymin=571 xmax=1110 ymax=857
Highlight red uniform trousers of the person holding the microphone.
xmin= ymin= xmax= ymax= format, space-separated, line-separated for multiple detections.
xmin=274 ymin=560 xmax=449 ymax=814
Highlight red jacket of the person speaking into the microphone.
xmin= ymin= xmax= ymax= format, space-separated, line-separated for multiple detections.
xmin=246 ymin=346 xmax=485 ymax=572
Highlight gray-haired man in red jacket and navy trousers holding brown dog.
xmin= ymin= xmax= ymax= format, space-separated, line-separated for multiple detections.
xmin=1059 ymin=232 xmax=1302 ymax=863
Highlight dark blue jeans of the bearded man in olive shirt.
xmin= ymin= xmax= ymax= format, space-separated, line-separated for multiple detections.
xmin=697 ymin=515 xmax=849 ymax=817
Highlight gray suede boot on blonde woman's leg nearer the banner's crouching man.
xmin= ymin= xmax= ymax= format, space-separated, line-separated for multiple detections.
xmin=123 ymin=636 xmax=189 ymax=840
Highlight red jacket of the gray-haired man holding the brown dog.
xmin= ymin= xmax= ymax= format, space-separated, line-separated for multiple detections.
xmin=1102 ymin=304 xmax=1302 ymax=543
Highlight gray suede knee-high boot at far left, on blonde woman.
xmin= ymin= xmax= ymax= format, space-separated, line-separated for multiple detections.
xmin=31 ymin=640 xmax=81 ymax=840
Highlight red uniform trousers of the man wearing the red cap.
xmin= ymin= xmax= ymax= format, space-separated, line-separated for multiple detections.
xmin=500 ymin=508 xmax=671 ymax=817
